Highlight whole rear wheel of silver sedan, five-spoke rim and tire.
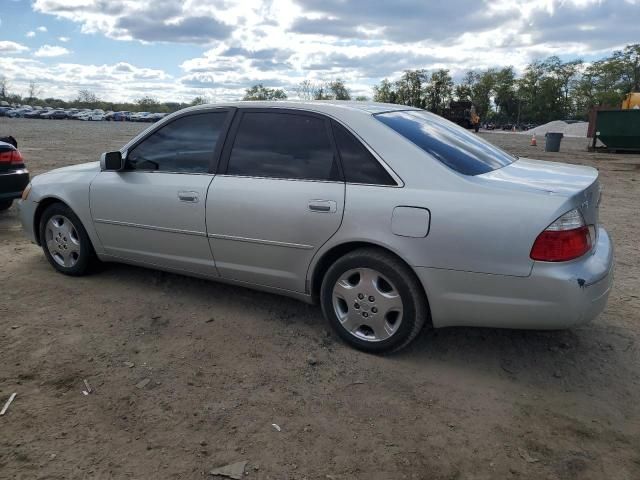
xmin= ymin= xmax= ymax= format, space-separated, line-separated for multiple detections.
xmin=320 ymin=248 xmax=429 ymax=353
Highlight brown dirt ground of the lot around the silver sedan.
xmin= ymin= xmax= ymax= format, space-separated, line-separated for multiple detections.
xmin=0 ymin=118 xmax=640 ymax=480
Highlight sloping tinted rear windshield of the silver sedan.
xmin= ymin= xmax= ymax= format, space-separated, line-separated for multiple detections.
xmin=375 ymin=110 xmax=516 ymax=175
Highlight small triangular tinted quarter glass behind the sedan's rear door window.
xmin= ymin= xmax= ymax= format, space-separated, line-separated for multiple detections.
xmin=331 ymin=122 xmax=396 ymax=185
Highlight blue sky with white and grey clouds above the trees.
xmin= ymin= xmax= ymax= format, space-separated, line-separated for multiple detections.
xmin=0 ymin=0 xmax=640 ymax=102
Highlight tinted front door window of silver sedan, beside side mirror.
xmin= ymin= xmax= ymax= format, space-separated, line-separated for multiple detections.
xmin=127 ymin=111 xmax=228 ymax=173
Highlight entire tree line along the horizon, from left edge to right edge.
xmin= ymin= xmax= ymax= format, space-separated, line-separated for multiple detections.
xmin=0 ymin=43 xmax=640 ymax=123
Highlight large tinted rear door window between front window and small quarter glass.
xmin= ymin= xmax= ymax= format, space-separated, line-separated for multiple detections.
xmin=227 ymin=112 xmax=340 ymax=180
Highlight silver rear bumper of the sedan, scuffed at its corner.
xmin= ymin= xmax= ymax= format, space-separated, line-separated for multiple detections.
xmin=416 ymin=228 xmax=614 ymax=329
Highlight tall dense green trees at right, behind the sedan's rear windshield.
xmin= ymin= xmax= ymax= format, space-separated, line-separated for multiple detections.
xmin=373 ymin=44 xmax=640 ymax=123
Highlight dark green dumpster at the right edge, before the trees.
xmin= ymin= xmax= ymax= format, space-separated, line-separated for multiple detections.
xmin=596 ymin=109 xmax=640 ymax=150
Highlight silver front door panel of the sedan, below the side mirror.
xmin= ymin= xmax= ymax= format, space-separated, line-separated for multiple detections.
xmin=90 ymin=171 xmax=215 ymax=275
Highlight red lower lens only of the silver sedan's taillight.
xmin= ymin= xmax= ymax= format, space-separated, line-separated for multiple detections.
xmin=531 ymin=227 xmax=591 ymax=262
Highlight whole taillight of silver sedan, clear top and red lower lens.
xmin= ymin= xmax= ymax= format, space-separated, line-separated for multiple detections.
xmin=531 ymin=209 xmax=592 ymax=262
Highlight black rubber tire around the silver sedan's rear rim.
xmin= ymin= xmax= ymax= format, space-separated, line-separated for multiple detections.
xmin=320 ymin=248 xmax=429 ymax=354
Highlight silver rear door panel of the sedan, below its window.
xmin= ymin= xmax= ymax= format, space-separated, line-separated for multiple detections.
xmin=207 ymin=175 xmax=345 ymax=292
